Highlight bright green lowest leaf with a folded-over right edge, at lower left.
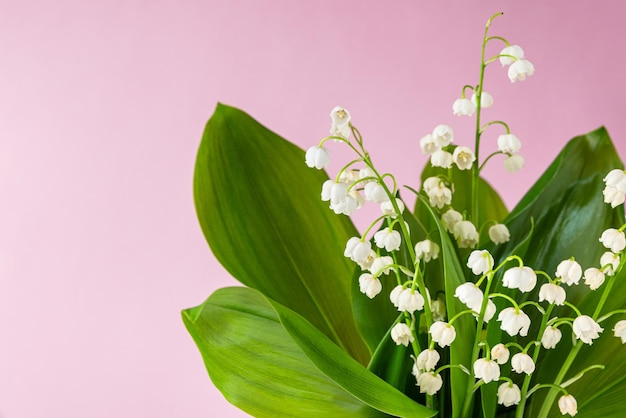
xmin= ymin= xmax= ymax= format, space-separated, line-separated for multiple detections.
xmin=183 ymin=288 xmax=435 ymax=417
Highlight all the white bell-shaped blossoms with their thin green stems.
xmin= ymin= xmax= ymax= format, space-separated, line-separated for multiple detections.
xmin=305 ymin=12 xmax=626 ymax=416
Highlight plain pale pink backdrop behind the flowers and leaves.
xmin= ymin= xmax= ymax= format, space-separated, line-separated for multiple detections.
xmin=0 ymin=0 xmax=626 ymax=418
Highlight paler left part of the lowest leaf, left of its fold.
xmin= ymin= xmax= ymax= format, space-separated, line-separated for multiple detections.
xmin=183 ymin=287 xmax=384 ymax=418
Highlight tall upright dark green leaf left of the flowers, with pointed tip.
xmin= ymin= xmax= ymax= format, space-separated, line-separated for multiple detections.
xmin=194 ymin=105 xmax=369 ymax=364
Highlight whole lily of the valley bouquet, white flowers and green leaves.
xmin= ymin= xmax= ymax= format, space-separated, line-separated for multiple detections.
xmin=183 ymin=15 xmax=626 ymax=418
